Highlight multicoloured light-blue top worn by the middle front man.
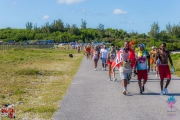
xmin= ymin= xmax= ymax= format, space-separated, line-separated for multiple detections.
xmin=137 ymin=51 xmax=147 ymax=70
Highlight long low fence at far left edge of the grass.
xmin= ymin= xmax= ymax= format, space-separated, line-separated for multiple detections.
xmin=0 ymin=44 xmax=54 ymax=50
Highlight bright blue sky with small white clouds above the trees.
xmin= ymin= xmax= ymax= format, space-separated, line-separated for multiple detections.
xmin=0 ymin=0 xmax=180 ymax=34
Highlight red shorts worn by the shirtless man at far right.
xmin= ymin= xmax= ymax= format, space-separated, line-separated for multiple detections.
xmin=158 ymin=64 xmax=171 ymax=80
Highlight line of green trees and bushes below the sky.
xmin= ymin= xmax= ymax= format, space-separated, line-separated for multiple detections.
xmin=0 ymin=19 xmax=180 ymax=49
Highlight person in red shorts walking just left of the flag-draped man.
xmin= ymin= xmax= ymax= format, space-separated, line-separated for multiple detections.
xmin=107 ymin=46 xmax=116 ymax=81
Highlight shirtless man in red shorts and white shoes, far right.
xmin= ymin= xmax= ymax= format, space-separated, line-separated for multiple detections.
xmin=156 ymin=43 xmax=174 ymax=95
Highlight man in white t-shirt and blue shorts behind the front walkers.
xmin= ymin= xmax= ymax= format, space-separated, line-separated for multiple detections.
xmin=100 ymin=45 xmax=108 ymax=71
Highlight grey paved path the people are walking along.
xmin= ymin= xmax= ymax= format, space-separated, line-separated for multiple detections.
xmin=53 ymin=59 xmax=180 ymax=120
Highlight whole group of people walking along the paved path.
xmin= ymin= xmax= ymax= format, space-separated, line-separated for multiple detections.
xmin=85 ymin=41 xmax=173 ymax=95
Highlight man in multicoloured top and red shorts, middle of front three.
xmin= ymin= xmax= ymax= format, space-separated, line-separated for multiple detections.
xmin=134 ymin=44 xmax=150 ymax=94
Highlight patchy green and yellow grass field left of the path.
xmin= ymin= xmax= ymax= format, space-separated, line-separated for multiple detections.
xmin=0 ymin=48 xmax=83 ymax=120
